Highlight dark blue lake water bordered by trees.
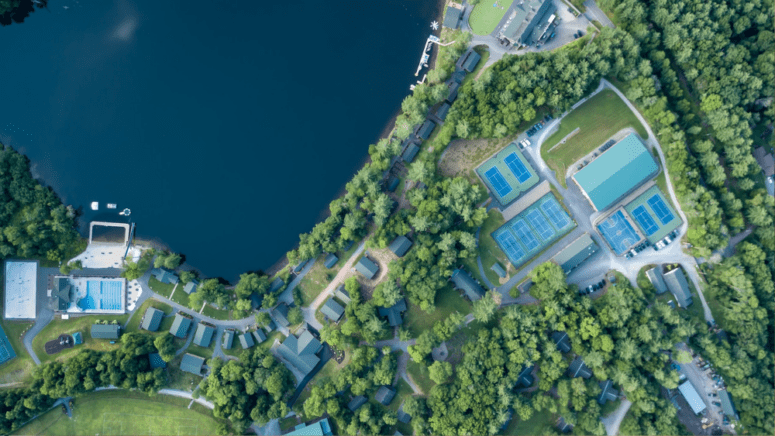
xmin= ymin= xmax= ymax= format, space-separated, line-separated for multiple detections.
xmin=0 ymin=0 xmax=439 ymax=279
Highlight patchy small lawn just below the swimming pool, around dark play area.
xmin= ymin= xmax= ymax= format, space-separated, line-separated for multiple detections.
xmin=32 ymin=315 xmax=129 ymax=363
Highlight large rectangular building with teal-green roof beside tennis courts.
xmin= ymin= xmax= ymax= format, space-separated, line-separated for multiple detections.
xmin=572 ymin=133 xmax=659 ymax=211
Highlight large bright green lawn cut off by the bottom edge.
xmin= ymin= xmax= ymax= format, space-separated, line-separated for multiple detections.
xmin=14 ymin=390 xmax=224 ymax=435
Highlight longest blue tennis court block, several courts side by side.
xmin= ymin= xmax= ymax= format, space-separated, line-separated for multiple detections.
xmin=492 ymin=193 xmax=575 ymax=267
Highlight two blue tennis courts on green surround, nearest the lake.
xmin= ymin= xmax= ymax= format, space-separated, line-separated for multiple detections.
xmin=476 ymin=143 xmax=538 ymax=205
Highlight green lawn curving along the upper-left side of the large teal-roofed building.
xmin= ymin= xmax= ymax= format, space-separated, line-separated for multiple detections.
xmin=541 ymin=89 xmax=648 ymax=186
